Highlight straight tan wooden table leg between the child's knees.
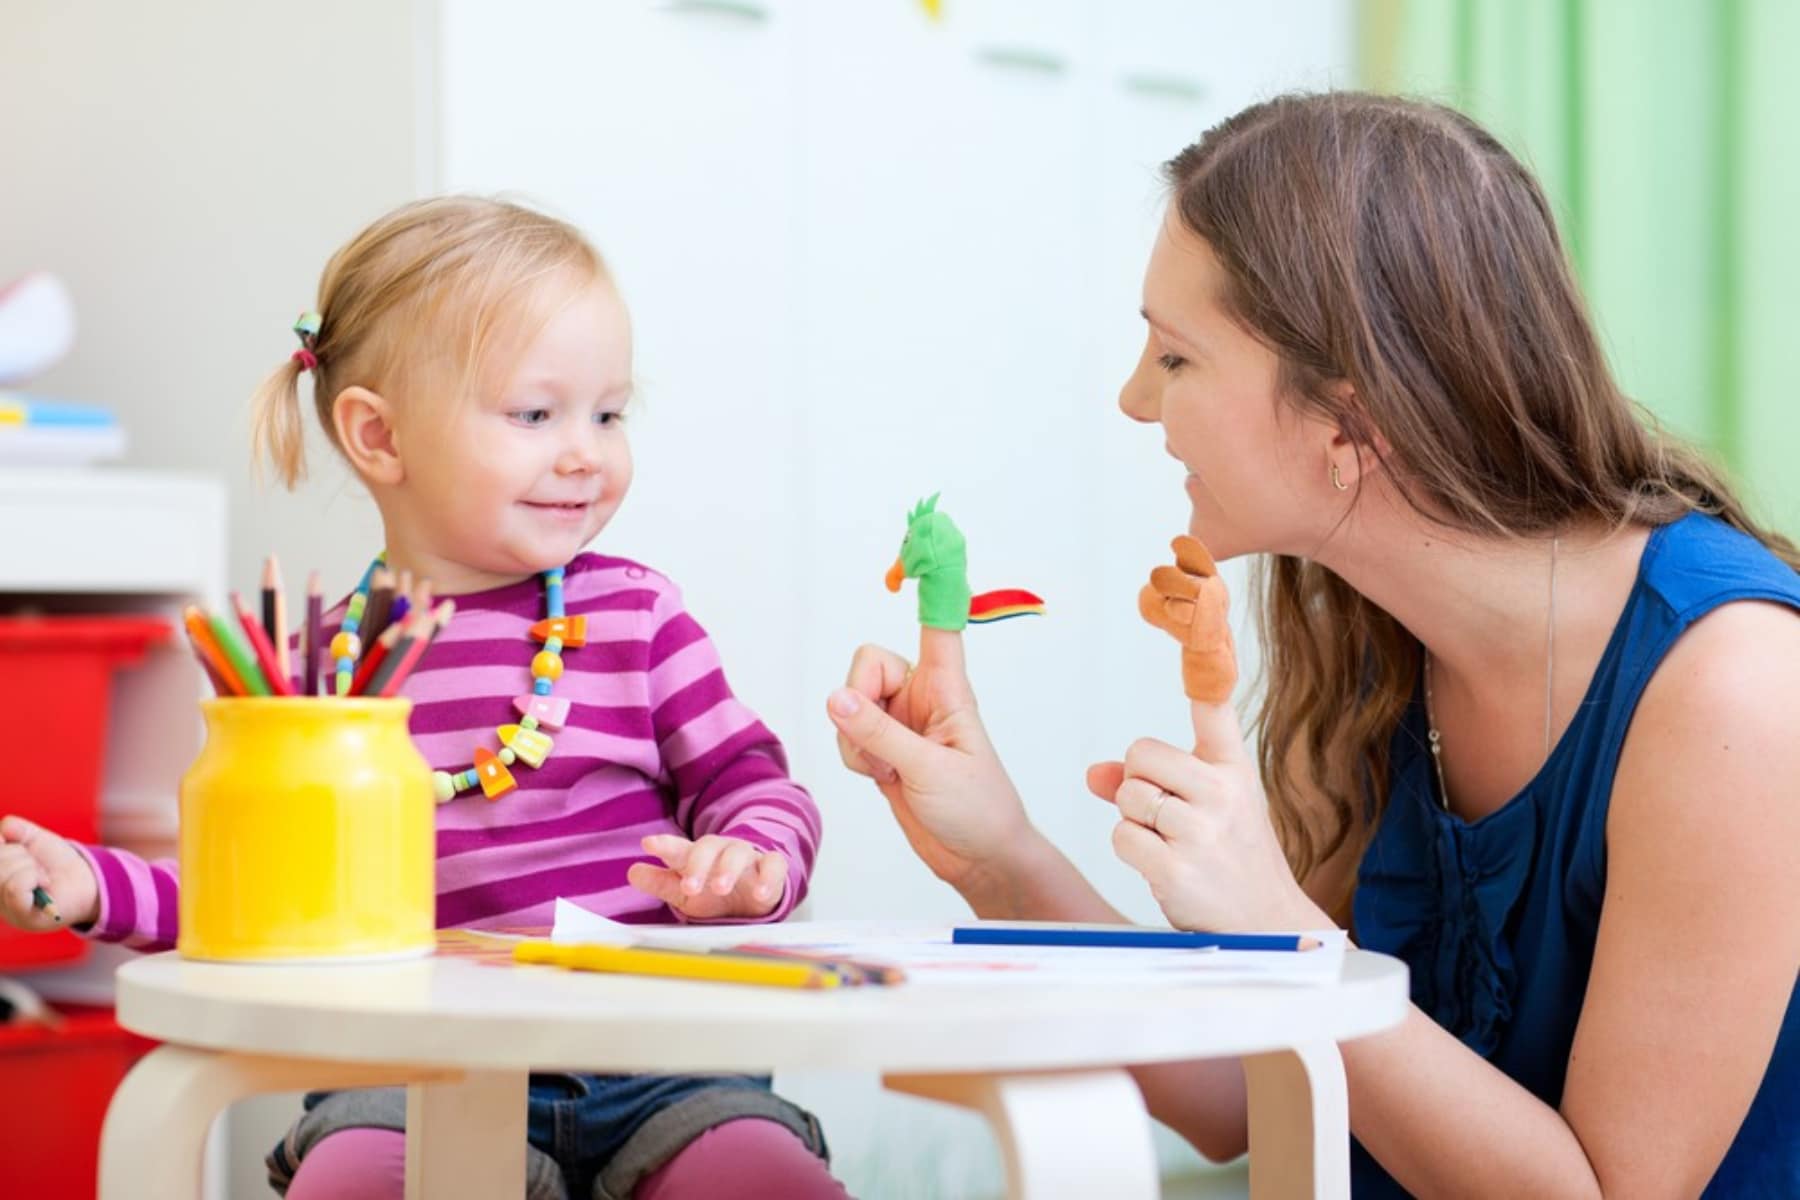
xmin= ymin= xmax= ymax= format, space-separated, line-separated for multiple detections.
xmin=407 ymin=1070 xmax=529 ymax=1200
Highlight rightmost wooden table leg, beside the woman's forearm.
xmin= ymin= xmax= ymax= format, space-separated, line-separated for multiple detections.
xmin=1244 ymin=1042 xmax=1350 ymax=1200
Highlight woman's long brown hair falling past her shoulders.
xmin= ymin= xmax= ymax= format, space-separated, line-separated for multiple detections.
xmin=1165 ymin=92 xmax=1800 ymax=892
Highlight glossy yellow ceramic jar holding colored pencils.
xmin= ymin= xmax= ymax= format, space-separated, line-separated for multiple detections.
xmin=176 ymin=696 xmax=436 ymax=963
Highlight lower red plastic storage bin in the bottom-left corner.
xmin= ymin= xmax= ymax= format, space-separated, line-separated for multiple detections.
xmin=0 ymin=1006 xmax=157 ymax=1200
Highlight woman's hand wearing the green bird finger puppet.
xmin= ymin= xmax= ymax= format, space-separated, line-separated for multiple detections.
xmin=826 ymin=628 xmax=1033 ymax=896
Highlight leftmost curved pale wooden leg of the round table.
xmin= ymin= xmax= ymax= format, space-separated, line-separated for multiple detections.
xmin=99 ymin=1045 xmax=457 ymax=1200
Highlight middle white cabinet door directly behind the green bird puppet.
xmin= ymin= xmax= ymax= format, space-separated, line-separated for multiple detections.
xmin=801 ymin=0 xmax=1096 ymax=916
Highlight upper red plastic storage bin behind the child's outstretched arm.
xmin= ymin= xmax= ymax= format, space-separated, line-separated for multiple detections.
xmin=0 ymin=617 xmax=175 ymax=971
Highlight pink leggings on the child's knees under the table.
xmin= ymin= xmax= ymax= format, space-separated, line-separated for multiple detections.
xmin=288 ymin=1117 xmax=848 ymax=1200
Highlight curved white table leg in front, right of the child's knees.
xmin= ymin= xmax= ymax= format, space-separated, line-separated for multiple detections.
xmin=882 ymin=1067 xmax=1159 ymax=1200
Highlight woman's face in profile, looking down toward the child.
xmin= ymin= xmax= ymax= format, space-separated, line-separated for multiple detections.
xmin=1120 ymin=210 xmax=1339 ymax=558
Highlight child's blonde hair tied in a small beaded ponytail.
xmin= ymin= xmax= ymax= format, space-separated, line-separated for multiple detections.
xmin=252 ymin=196 xmax=607 ymax=488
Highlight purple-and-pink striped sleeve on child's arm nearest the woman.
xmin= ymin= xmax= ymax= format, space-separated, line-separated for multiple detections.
xmin=650 ymin=585 xmax=821 ymax=921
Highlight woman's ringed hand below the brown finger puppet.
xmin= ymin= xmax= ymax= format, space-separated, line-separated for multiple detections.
xmin=1087 ymin=703 xmax=1332 ymax=932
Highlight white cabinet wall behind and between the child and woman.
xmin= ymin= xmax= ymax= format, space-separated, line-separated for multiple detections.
xmin=437 ymin=0 xmax=1352 ymax=1196
